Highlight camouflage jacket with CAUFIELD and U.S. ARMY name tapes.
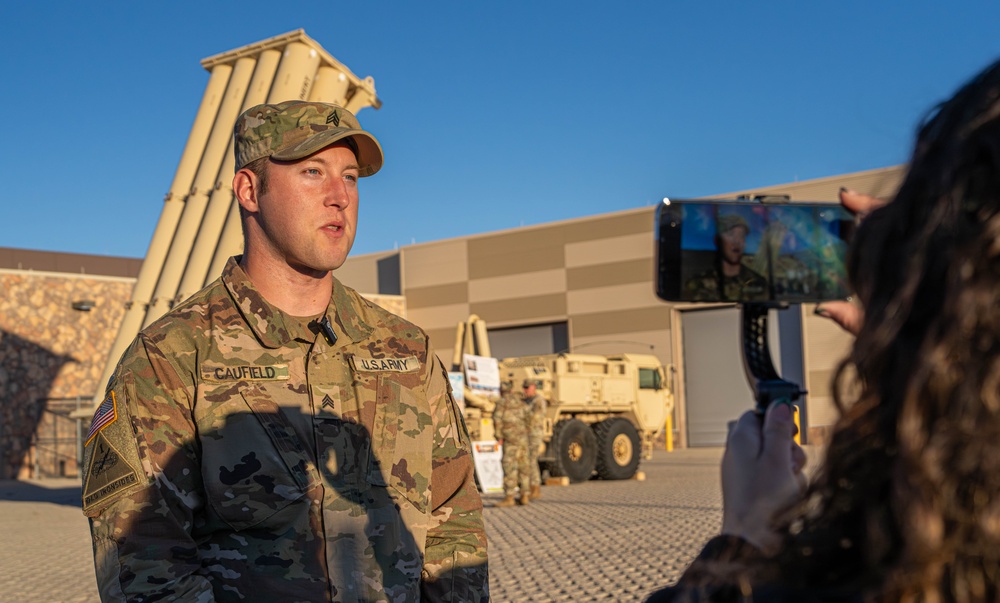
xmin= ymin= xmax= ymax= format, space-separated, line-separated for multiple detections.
xmin=84 ymin=259 xmax=489 ymax=602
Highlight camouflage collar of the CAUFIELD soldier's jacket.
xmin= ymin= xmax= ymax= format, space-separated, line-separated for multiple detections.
xmin=222 ymin=256 xmax=373 ymax=349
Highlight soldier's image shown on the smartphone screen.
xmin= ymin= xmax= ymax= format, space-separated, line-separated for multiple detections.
xmin=684 ymin=214 xmax=768 ymax=301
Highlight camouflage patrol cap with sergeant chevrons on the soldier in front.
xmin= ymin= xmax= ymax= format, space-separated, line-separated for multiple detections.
xmin=233 ymin=100 xmax=382 ymax=176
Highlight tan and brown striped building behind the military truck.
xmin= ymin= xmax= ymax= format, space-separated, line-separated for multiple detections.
xmin=337 ymin=167 xmax=902 ymax=446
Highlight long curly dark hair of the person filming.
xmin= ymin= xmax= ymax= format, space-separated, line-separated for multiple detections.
xmin=777 ymin=61 xmax=1000 ymax=602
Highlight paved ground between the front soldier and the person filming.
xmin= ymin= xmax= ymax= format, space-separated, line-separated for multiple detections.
xmin=485 ymin=448 xmax=722 ymax=603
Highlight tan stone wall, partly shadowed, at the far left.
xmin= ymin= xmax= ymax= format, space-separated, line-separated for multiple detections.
xmin=0 ymin=272 xmax=135 ymax=479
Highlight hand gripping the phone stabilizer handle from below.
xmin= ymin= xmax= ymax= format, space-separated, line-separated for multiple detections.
xmin=722 ymin=402 xmax=806 ymax=552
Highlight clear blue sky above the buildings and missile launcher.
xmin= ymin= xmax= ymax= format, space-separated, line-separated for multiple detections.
xmin=0 ymin=0 xmax=1000 ymax=257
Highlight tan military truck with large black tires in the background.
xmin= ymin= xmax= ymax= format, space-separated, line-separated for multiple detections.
xmin=453 ymin=316 xmax=674 ymax=482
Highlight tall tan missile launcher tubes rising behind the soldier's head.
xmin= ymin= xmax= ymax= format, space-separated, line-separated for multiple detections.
xmin=81 ymin=30 xmax=382 ymax=416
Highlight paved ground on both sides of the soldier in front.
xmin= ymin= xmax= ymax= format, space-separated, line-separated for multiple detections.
xmin=0 ymin=448 xmax=744 ymax=603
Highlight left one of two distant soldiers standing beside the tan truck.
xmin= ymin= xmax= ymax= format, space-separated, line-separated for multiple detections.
xmin=493 ymin=381 xmax=531 ymax=507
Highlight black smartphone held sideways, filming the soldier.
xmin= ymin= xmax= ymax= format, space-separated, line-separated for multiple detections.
xmin=656 ymin=197 xmax=855 ymax=303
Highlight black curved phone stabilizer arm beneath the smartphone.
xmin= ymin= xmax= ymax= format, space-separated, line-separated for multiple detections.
xmin=742 ymin=303 xmax=806 ymax=414
